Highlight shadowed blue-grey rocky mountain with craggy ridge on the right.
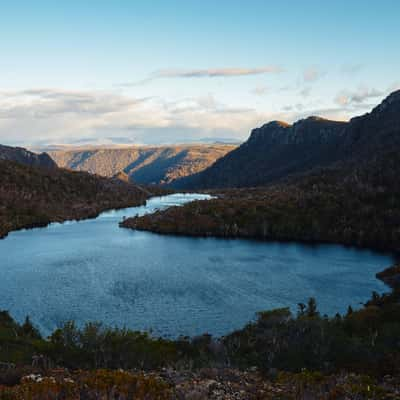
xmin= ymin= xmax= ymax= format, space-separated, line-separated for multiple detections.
xmin=174 ymin=91 xmax=400 ymax=189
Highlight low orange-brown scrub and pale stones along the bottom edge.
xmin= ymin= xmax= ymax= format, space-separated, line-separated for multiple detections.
xmin=0 ymin=368 xmax=400 ymax=400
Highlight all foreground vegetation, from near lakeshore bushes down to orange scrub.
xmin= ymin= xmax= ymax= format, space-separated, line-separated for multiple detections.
xmin=0 ymin=266 xmax=400 ymax=399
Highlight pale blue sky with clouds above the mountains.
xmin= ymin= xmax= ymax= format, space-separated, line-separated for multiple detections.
xmin=0 ymin=0 xmax=400 ymax=146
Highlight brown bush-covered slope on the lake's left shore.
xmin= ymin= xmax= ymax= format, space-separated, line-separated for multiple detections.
xmin=0 ymin=160 xmax=149 ymax=237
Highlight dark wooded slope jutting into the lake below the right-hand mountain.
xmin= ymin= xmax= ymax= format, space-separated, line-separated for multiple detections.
xmin=122 ymin=151 xmax=400 ymax=251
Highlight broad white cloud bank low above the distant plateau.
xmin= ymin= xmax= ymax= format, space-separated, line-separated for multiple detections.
xmin=0 ymin=88 xmax=282 ymax=145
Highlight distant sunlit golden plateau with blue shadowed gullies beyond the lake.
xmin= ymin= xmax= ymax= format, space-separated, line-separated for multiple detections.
xmin=49 ymin=144 xmax=236 ymax=184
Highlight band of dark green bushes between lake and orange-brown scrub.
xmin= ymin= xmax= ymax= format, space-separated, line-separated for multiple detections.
xmin=0 ymin=268 xmax=400 ymax=383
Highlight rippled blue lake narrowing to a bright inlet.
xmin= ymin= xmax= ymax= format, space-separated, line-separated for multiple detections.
xmin=0 ymin=194 xmax=393 ymax=337
